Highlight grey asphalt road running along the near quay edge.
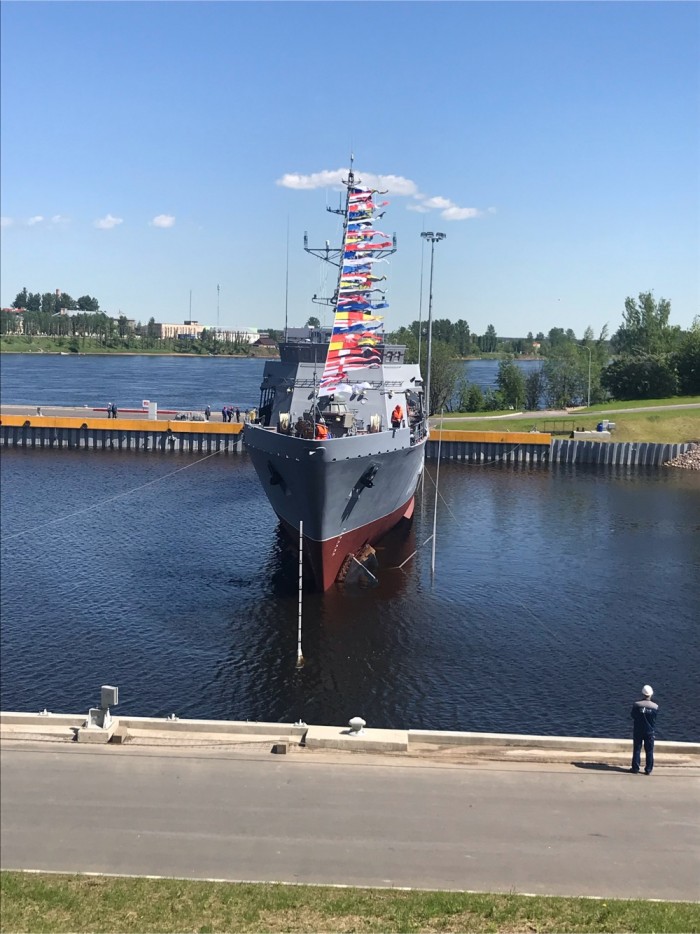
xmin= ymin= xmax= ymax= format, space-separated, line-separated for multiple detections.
xmin=0 ymin=743 xmax=700 ymax=899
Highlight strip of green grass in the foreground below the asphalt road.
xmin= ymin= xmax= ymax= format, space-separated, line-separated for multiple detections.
xmin=0 ymin=872 xmax=700 ymax=934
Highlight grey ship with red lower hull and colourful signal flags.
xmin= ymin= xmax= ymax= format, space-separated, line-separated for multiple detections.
xmin=244 ymin=162 xmax=428 ymax=591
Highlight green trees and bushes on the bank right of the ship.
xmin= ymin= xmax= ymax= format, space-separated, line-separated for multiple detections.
xmin=388 ymin=292 xmax=700 ymax=413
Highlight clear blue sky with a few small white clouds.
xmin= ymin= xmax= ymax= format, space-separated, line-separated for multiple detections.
xmin=1 ymin=2 xmax=700 ymax=336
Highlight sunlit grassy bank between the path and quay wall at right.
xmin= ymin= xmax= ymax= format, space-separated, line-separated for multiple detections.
xmin=440 ymin=408 xmax=700 ymax=444
